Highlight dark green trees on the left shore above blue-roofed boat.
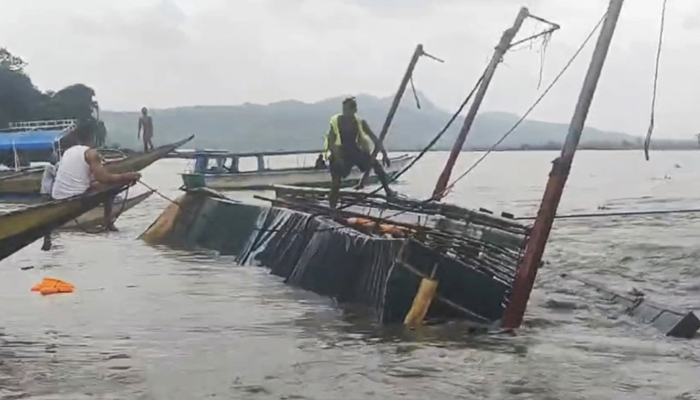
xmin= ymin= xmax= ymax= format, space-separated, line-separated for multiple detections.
xmin=0 ymin=48 xmax=107 ymax=145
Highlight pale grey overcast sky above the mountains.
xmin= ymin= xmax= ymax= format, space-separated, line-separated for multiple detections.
xmin=0 ymin=0 xmax=700 ymax=137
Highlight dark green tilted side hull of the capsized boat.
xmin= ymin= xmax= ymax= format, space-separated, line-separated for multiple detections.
xmin=141 ymin=191 xmax=518 ymax=326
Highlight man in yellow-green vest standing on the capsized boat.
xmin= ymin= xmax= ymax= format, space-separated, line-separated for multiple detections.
xmin=325 ymin=97 xmax=395 ymax=208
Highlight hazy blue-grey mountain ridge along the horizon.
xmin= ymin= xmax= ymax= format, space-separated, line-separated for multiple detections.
xmin=100 ymin=94 xmax=641 ymax=152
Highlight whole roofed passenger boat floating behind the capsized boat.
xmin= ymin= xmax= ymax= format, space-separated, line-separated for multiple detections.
xmin=182 ymin=152 xmax=415 ymax=191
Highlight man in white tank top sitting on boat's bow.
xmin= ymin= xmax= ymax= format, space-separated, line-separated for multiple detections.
xmin=42 ymin=125 xmax=141 ymax=250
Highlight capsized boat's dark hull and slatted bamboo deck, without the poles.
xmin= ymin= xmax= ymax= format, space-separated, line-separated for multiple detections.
xmin=141 ymin=187 xmax=529 ymax=327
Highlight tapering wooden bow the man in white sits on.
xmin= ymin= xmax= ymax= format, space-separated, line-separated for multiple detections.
xmin=0 ymin=187 xmax=126 ymax=260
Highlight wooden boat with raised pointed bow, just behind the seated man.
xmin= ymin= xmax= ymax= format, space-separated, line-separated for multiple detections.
xmin=0 ymin=135 xmax=194 ymax=196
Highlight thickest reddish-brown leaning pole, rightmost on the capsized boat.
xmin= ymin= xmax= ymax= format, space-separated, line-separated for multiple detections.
xmin=503 ymin=0 xmax=624 ymax=329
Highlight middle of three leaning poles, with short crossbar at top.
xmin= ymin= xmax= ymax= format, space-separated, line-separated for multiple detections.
xmin=433 ymin=7 xmax=530 ymax=200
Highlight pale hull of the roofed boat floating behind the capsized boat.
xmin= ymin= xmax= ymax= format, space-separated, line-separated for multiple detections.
xmin=182 ymin=156 xmax=414 ymax=191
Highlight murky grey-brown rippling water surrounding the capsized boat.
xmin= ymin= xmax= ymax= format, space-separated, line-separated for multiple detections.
xmin=0 ymin=152 xmax=700 ymax=400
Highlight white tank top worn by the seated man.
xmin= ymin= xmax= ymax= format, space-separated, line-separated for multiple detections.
xmin=51 ymin=145 xmax=92 ymax=200
